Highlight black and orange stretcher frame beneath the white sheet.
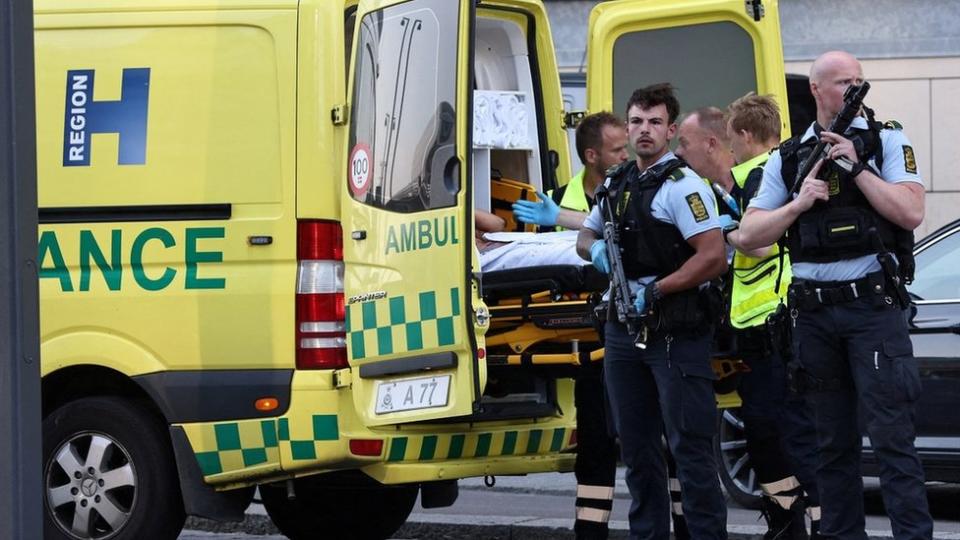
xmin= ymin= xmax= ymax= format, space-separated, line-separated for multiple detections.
xmin=480 ymin=265 xmax=744 ymax=394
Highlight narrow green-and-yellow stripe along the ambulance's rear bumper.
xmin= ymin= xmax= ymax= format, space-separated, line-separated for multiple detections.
xmin=387 ymin=428 xmax=571 ymax=462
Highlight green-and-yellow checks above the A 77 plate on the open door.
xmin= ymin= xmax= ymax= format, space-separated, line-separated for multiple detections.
xmin=346 ymin=287 xmax=460 ymax=360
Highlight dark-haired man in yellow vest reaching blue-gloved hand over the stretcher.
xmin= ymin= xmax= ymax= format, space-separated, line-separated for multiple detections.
xmin=513 ymin=112 xmax=627 ymax=540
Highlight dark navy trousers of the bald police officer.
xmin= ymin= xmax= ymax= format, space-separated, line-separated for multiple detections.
xmin=793 ymin=295 xmax=933 ymax=540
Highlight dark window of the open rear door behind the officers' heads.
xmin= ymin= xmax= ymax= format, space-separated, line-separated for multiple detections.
xmin=613 ymin=21 xmax=757 ymax=117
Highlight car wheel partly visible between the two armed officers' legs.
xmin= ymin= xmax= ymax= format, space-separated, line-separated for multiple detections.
xmin=714 ymin=408 xmax=762 ymax=510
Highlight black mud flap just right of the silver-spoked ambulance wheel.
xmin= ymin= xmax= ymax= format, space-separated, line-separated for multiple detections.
xmin=170 ymin=426 xmax=256 ymax=521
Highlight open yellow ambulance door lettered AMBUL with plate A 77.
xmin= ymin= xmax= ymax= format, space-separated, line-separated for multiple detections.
xmin=342 ymin=0 xmax=485 ymax=426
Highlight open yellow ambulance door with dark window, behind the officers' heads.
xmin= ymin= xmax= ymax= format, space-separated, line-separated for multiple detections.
xmin=587 ymin=0 xmax=789 ymax=137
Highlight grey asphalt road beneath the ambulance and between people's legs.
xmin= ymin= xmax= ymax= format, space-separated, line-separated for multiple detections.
xmin=180 ymin=471 xmax=960 ymax=540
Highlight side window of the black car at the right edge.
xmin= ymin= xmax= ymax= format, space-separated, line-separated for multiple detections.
xmin=908 ymin=229 xmax=960 ymax=300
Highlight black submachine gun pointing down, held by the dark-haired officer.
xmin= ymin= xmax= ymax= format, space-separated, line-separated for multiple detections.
xmin=596 ymin=162 xmax=647 ymax=349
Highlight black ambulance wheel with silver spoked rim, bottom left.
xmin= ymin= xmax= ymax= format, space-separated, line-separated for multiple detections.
xmin=43 ymin=397 xmax=185 ymax=540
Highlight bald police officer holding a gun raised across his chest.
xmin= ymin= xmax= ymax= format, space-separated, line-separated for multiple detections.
xmin=739 ymin=51 xmax=933 ymax=539
